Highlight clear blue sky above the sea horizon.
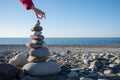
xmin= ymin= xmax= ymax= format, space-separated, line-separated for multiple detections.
xmin=0 ymin=0 xmax=120 ymax=38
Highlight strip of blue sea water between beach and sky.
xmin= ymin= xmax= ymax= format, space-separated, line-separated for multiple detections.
xmin=0 ymin=38 xmax=120 ymax=45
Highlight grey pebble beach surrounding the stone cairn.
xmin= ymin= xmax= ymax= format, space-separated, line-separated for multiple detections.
xmin=0 ymin=44 xmax=120 ymax=80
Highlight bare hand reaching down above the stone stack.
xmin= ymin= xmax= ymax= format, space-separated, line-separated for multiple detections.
xmin=31 ymin=6 xmax=46 ymax=19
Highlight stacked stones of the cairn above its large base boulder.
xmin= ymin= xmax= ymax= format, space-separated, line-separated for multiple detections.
xmin=26 ymin=20 xmax=49 ymax=62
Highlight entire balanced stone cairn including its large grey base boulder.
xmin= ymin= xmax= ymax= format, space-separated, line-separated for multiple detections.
xmin=23 ymin=21 xmax=61 ymax=76
